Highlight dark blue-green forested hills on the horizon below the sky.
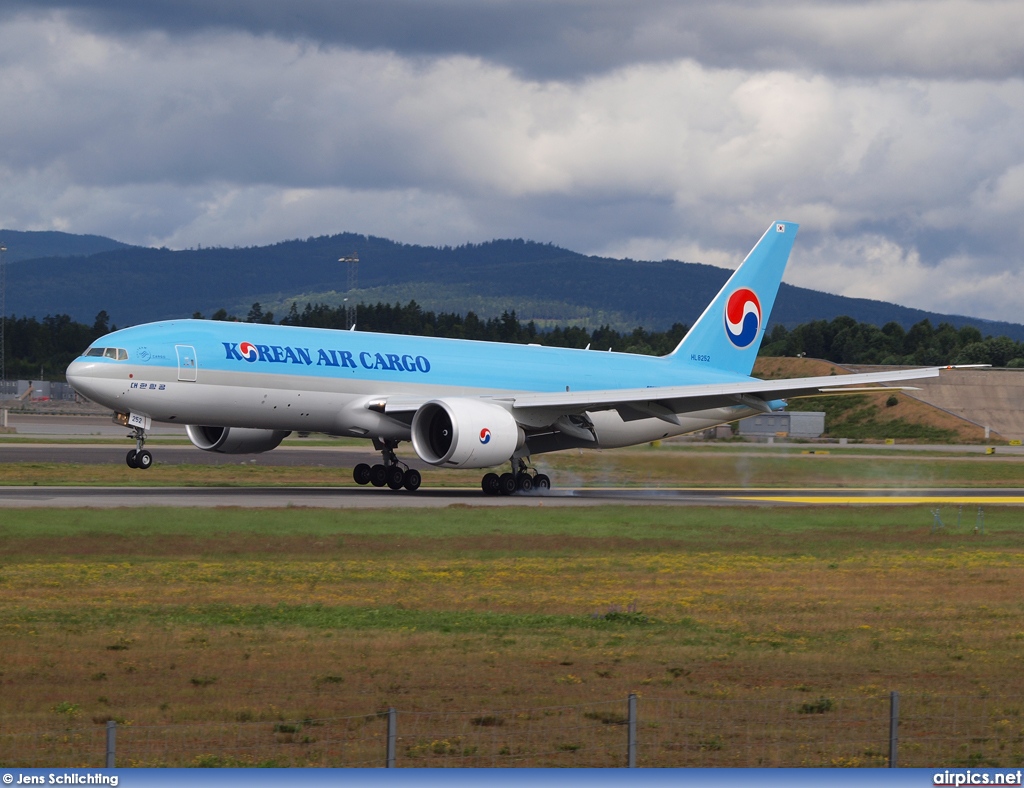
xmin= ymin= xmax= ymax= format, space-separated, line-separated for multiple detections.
xmin=7 ymin=227 xmax=1024 ymax=340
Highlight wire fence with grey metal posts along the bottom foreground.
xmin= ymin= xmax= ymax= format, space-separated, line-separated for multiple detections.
xmin=0 ymin=693 xmax=1024 ymax=768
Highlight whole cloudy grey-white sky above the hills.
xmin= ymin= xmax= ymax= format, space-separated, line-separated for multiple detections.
xmin=0 ymin=0 xmax=1024 ymax=322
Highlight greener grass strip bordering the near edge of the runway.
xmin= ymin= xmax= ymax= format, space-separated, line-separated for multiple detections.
xmin=0 ymin=506 xmax=1024 ymax=540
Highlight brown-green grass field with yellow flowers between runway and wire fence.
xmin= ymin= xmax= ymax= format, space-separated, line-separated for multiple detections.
xmin=0 ymin=499 xmax=1024 ymax=764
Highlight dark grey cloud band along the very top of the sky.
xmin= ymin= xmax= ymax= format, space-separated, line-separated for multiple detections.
xmin=7 ymin=0 xmax=1024 ymax=79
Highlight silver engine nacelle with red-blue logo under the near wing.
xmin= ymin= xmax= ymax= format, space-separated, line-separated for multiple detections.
xmin=413 ymin=397 xmax=525 ymax=468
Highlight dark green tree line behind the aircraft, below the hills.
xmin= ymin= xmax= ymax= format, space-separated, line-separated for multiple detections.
xmin=4 ymin=301 xmax=1024 ymax=380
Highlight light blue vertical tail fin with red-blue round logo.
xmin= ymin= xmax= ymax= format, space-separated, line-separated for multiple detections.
xmin=669 ymin=216 xmax=799 ymax=375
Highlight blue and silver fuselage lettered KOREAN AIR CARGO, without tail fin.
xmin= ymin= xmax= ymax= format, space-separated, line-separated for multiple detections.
xmin=61 ymin=320 xmax=753 ymax=446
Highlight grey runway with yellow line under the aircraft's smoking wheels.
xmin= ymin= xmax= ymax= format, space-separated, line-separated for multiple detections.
xmin=0 ymin=485 xmax=1024 ymax=509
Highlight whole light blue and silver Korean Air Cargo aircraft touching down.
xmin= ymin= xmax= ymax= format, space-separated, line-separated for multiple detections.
xmin=68 ymin=222 xmax=939 ymax=495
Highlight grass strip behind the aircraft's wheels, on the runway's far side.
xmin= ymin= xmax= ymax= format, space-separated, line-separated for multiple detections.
xmin=0 ymin=444 xmax=1024 ymax=488
